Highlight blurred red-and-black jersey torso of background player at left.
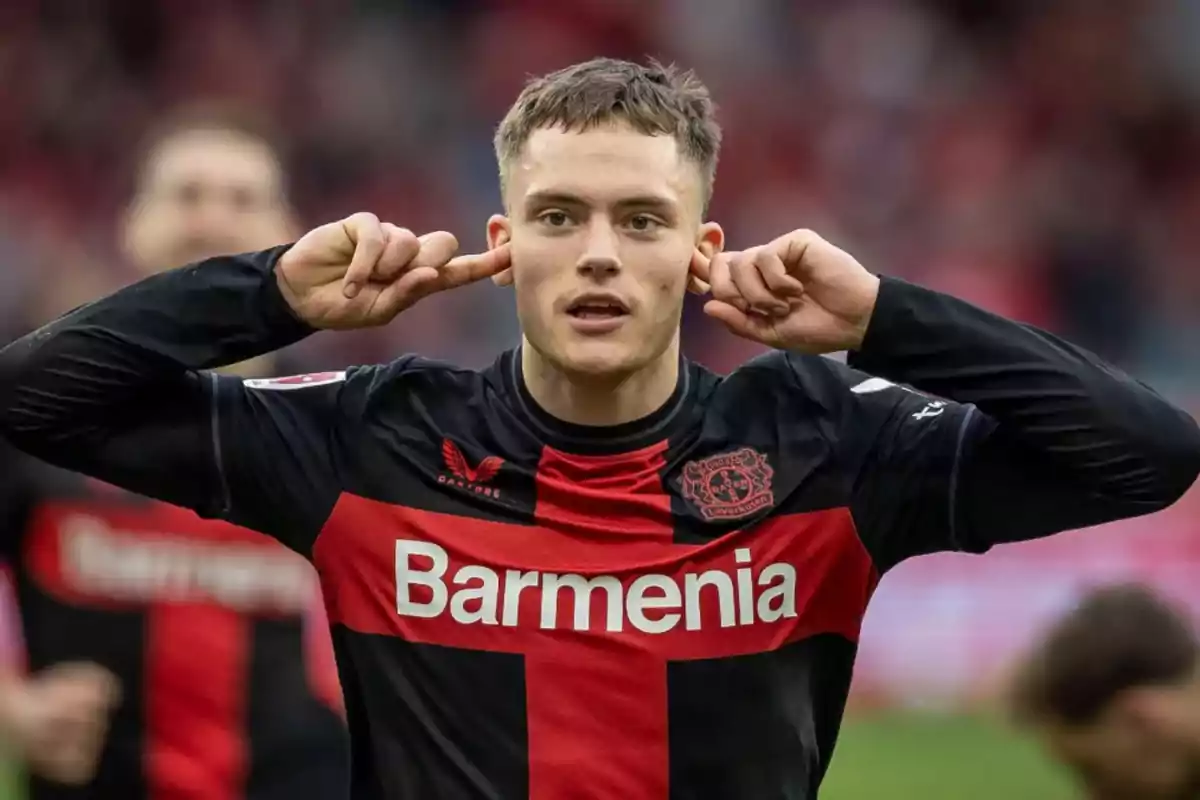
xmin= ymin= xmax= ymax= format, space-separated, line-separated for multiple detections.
xmin=14 ymin=465 xmax=346 ymax=800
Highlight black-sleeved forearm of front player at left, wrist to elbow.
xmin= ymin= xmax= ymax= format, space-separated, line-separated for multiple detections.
xmin=0 ymin=248 xmax=310 ymax=449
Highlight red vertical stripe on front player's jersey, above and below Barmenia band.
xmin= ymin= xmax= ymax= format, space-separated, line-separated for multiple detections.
xmin=526 ymin=441 xmax=673 ymax=800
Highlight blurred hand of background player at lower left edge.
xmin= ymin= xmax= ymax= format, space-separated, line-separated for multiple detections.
xmin=0 ymin=663 xmax=121 ymax=786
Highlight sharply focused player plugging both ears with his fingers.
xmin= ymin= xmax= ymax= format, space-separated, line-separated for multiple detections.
xmin=0 ymin=59 xmax=1200 ymax=800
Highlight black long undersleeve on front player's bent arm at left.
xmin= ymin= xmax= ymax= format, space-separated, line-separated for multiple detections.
xmin=0 ymin=249 xmax=310 ymax=515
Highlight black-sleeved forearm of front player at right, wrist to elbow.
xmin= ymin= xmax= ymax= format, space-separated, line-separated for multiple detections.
xmin=851 ymin=279 xmax=1200 ymax=509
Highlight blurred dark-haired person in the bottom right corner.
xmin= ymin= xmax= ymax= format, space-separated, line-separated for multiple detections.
xmin=1013 ymin=585 xmax=1200 ymax=800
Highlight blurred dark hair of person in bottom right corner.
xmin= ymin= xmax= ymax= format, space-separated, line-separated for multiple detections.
xmin=1012 ymin=584 xmax=1200 ymax=724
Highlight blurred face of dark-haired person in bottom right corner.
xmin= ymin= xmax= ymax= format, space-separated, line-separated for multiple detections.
xmin=1040 ymin=708 xmax=1200 ymax=800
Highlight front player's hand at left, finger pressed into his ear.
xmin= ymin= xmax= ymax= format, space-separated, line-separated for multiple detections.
xmin=275 ymin=212 xmax=510 ymax=329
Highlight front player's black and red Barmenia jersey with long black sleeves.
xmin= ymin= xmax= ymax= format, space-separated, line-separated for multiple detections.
xmin=0 ymin=248 xmax=1200 ymax=800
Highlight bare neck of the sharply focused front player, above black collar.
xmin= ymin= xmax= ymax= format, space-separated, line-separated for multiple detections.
xmin=521 ymin=337 xmax=679 ymax=426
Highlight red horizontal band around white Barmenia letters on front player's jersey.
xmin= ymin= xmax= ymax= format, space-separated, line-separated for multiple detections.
xmin=314 ymin=494 xmax=874 ymax=660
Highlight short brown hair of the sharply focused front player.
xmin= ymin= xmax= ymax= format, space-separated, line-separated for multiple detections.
xmin=494 ymin=59 xmax=721 ymax=204
